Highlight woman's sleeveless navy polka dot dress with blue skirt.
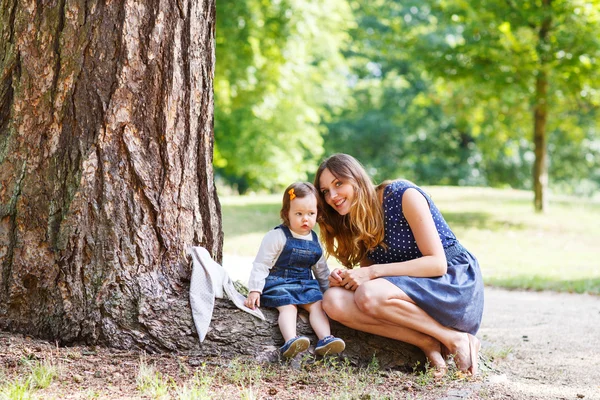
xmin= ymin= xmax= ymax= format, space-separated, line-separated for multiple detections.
xmin=368 ymin=180 xmax=483 ymax=335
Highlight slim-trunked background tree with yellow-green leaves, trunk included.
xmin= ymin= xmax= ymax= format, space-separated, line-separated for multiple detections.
xmin=414 ymin=0 xmax=600 ymax=211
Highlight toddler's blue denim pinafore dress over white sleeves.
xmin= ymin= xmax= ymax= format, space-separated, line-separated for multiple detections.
xmin=260 ymin=225 xmax=323 ymax=307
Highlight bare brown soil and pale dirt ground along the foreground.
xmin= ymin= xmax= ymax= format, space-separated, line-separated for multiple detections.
xmin=0 ymin=288 xmax=600 ymax=400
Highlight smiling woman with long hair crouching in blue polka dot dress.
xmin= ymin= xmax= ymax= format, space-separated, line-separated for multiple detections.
xmin=315 ymin=154 xmax=483 ymax=375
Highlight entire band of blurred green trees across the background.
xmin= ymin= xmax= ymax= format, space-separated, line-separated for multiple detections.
xmin=215 ymin=0 xmax=600 ymax=211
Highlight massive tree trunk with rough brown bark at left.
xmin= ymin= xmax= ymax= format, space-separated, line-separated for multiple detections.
xmin=0 ymin=0 xmax=223 ymax=351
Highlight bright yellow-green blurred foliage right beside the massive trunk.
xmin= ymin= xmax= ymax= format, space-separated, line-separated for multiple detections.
xmin=214 ymin=0 xmax=350 ymax=193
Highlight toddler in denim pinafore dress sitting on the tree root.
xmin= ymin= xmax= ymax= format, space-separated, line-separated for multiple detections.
xmin=245 ymin=182 xmax=346 ymax=358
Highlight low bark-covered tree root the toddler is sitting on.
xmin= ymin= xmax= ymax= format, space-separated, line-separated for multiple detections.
xmin=198 ymin=299 xmax=425 ymax=370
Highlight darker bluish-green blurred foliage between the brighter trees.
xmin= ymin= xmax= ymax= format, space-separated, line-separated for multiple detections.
xmin=325 ymin=1 xmax=481 ymax=185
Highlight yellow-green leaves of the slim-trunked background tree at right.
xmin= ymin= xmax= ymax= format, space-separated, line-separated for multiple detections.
xmin=414 ymin=0 xmax=600 ymax=193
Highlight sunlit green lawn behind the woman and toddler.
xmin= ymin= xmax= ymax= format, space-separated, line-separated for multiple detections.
xmin=220 ymin=187 xmax=600 ymax=294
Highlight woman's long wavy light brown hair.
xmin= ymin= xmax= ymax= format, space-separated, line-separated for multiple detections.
xmin=315 ymin=153 xmax=384 ymax=268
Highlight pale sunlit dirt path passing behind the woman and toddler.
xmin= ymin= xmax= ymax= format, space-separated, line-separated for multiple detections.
xmin=223 ymin=255 xmax=600 ymax=400
